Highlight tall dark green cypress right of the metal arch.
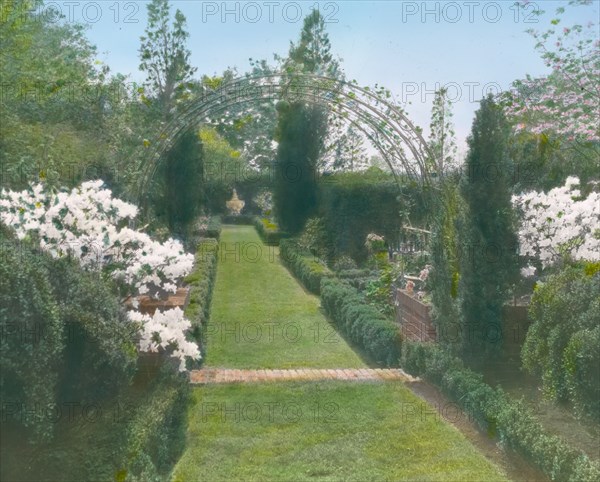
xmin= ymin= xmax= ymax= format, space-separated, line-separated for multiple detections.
xmin=459 ymin=95 xmax=518 ymax=357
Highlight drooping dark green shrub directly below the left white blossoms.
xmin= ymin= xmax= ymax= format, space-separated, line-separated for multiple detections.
xmin=48 ymin=258 xmax=138 ymax=403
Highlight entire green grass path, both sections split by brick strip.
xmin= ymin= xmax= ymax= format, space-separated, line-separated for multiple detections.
xmin=173 ymin=226 xmax=506 ymax=482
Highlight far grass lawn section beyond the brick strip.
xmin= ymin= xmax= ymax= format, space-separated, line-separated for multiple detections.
xmin=203 ymin=225 xmax=365 ymax=369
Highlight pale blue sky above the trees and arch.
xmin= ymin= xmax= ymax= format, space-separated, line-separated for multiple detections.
xmin=47 ymin=0 xmax=599 ymax=157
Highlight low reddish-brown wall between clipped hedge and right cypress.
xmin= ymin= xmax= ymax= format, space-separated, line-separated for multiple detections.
xmin=395 ymin=290 xmax=436 ymax=341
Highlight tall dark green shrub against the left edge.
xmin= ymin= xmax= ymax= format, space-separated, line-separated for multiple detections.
xmin=0 ymin=233 xmax=65 ymax=439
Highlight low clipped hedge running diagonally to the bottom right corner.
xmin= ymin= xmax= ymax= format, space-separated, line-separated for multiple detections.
xmin=401 ymin=342 xmax=600 ymax=482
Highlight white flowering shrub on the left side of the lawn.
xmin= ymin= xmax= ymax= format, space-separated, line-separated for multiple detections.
xmin=0 ymin=181 xmax=199 ymax=366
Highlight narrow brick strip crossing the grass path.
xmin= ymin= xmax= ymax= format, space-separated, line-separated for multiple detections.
xmin=190 ymin=368 xmax=417 ymax=385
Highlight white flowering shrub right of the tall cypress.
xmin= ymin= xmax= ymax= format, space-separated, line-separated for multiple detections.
xmin=512 ymin=177 xmax=600 ymax=266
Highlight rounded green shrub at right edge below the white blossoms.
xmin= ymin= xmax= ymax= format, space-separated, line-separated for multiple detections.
xmin=522 ymin=266 xmax=600 ymax=421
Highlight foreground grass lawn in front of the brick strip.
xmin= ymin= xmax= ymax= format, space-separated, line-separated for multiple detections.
xmin=173 ymin=381 xmax=507 ymax=482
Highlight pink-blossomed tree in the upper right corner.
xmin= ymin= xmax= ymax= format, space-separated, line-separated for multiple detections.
xmin=503 ymin=0 xmax=600 ymax=193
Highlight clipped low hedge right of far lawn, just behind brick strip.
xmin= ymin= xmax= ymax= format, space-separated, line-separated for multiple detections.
xmin=321 ymin=278 xmax=401 ymax=366
